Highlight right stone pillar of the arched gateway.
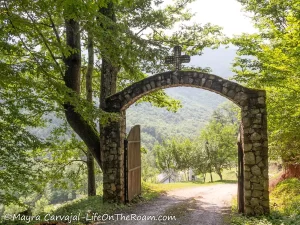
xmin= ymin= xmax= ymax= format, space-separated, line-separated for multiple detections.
xmin=242 ymin=91 xmax=270 ymax=215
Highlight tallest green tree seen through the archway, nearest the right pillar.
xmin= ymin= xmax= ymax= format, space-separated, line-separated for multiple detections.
xmin=192 ymin=103 xmax=238 ymax=180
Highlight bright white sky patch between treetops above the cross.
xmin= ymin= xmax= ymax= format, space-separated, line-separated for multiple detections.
xmin=184 ymin=0 xmax=255 ymax=36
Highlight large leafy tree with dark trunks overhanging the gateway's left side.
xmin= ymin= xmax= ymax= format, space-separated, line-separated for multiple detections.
xmin=1 ymin=0 xmax=225 ymax=165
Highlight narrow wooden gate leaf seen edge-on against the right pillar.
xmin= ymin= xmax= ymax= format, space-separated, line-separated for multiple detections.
xmin=237 ymin=126 xmax=245 ymax=213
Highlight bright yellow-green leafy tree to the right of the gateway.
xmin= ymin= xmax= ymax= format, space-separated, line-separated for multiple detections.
xmin=232 ymin=0 xmax=300 ymax=177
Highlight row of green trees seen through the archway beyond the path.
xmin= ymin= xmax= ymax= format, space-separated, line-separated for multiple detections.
xmin=154 ymin=103 xmax=238 ymax=180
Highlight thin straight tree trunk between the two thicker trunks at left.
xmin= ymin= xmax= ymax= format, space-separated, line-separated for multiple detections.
xmin=85 ymin=32 xmax=96 ymax=196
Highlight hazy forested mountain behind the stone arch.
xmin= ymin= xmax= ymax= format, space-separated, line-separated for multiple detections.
xmin=126 ymin=48 xmax=235 ymax=149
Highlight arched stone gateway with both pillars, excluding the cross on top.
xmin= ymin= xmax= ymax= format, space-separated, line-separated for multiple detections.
xmin=101 ymin=71 xmax=269 ymax=215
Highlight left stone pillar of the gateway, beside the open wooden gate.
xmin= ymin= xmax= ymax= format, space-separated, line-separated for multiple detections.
xmin=101 ymin=111 xmax=126 ymax=203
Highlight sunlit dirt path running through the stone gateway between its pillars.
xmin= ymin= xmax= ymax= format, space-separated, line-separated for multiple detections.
xmin=97 ymin=184 xmax=237 ymax=225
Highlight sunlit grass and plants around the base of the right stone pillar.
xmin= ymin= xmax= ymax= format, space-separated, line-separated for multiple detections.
xmin=231 ymin=178 xmax=300 ymax=225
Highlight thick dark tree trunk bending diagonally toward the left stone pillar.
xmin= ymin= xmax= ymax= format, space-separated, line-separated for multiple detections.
xmin=64 ymin=19 xmax=101 ymax=167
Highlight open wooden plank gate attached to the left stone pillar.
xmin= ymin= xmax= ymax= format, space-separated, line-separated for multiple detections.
xmin=124 ymin=125 xmax=142 ymax=202
